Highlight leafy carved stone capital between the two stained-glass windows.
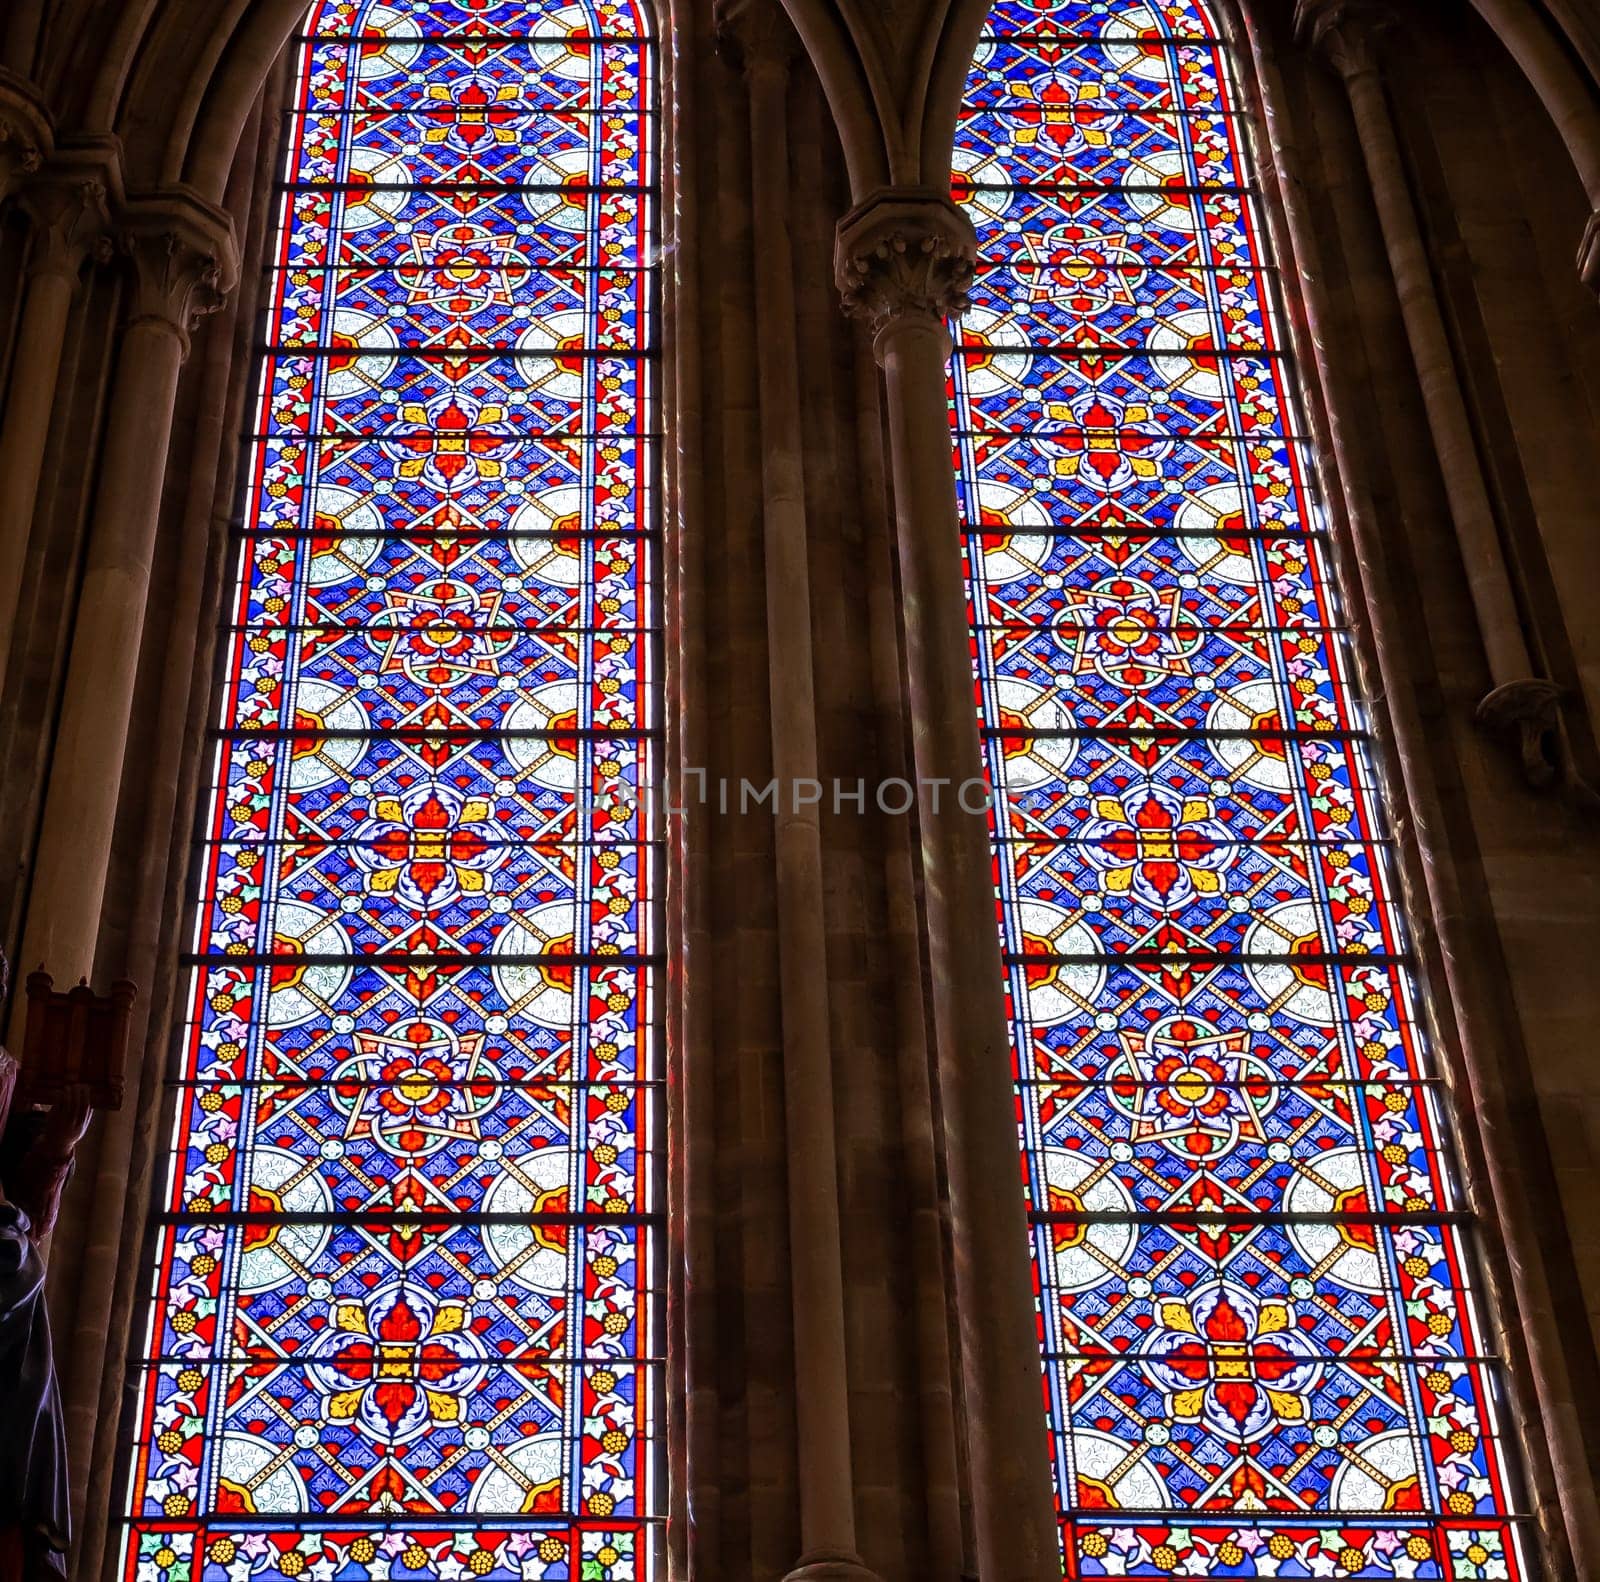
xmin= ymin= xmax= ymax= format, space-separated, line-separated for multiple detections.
xmin=834 ymin=187 xmax=978 ymax=347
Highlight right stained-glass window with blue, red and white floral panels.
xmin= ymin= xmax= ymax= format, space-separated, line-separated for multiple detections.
xmin=950 ymin=0 xmax=1530 ymax=1582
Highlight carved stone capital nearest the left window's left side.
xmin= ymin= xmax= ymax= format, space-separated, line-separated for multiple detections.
xmin=118 ymin=192 xmax=238 ymax=355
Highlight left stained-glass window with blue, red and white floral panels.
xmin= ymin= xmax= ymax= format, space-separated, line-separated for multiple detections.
xmin=123 ymin=0 xmax=661 ymax=1582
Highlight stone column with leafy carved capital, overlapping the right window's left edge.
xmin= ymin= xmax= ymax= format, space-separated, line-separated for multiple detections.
xmin=835 ymin=187 xmax=1061 ymax=1582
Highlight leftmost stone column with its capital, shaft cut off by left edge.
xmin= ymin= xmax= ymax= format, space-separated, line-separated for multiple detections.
xmin=0 ymin=171 xmax=110 ymax=686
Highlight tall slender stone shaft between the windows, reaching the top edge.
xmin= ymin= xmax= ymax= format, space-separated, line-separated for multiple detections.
xmin=717 ymin=0 xmax=875 ymax=1582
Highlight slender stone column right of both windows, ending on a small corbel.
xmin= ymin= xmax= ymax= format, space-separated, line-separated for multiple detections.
xmin=1296 ymin=0 xmax=1568 ymax=787
